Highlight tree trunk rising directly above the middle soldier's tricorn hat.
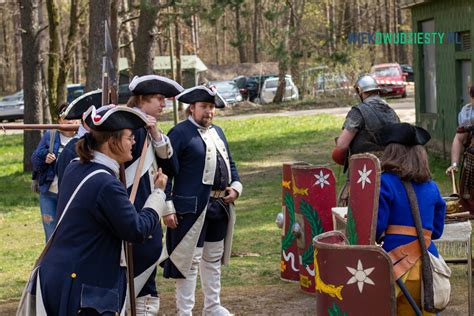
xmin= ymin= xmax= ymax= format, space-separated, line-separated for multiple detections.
xmin=132 ymin=0 xmax=160 ymax=76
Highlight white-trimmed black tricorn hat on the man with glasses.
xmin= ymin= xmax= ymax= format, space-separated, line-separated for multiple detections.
xmin=83 ymin=105 xmax=147 ymax=132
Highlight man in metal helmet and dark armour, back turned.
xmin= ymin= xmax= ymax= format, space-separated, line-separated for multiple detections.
xmin=332 ymin=75 xmax=400 ymax=206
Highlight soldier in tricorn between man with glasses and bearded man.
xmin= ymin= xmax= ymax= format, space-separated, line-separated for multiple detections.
xmin=125 ymin=75 xmax=183 ymax=316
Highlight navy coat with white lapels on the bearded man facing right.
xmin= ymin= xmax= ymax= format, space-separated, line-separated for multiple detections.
xmin=160 ymin=118 xmax=242 ymax=278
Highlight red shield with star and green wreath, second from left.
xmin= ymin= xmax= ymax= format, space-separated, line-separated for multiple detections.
xmin=292 ymin=166 xmax=336 ymax=293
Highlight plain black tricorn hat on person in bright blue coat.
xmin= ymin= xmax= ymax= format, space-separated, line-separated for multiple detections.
xmin=375 ymin=123 xmax=431 ymax=146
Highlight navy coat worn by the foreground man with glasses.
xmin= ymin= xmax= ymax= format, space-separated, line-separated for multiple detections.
xmin=32 ymin=161 xmax=164 ymax=315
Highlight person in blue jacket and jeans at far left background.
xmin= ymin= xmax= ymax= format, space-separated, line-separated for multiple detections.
xmin=31 ymin=103 xmax=76 ymax=242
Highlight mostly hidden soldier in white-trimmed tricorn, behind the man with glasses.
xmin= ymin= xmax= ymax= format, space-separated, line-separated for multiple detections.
xmin=55 ymin=89 xmax=102 ymax=187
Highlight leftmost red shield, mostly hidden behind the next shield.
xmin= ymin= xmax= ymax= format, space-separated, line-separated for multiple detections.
xmin=277 ymin=162 xmax=308 ymax=282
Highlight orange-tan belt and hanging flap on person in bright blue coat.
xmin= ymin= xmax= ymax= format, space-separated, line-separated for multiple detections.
xmin=385 ymin=225 xmax=431 ymax=279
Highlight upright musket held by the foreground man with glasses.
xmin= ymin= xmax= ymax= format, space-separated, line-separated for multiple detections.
xmin=102 ymin=20 xmax=137 ymax=316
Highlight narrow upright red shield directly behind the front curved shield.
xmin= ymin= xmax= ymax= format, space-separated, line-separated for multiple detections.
xmin=346 ymin=153 xmax=380 ymax=245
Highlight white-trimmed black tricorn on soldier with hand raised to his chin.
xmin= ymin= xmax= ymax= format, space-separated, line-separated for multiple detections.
xmin=128 ymin=75 xmax=184 ymax=98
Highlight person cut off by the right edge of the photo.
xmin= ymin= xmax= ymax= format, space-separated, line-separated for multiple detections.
xmin=446 ymin=86 xmax=474 ymax=214
